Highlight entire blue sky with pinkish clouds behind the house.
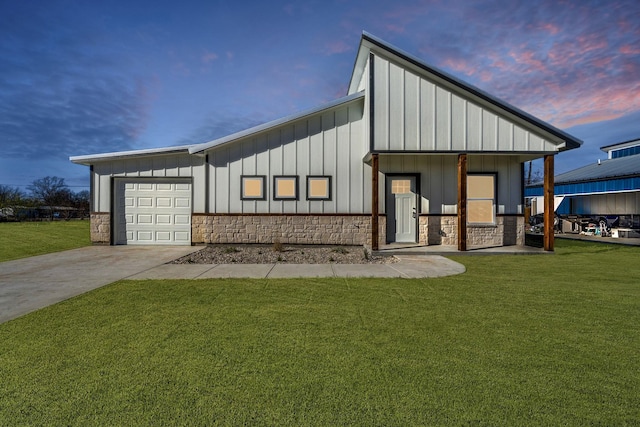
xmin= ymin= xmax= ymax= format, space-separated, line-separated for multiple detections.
xmin=0 ymin=0 xmax=640 ymax=191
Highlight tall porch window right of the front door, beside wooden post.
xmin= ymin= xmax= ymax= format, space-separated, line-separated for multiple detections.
xmin=467 ymin=174 xmax=496 ymax=224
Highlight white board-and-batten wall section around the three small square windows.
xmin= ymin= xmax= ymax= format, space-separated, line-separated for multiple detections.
xmin=207 ymin=99 xmax=371 ymax=214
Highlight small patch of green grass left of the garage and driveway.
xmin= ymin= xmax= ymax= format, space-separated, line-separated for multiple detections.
xmin=0 ymin=220 xmax=91 ymax=262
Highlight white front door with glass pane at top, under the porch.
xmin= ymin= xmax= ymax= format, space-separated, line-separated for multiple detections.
xmin=387 ymin=176 xmax=418 ymax=243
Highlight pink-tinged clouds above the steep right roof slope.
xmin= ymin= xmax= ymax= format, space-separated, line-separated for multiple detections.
xmin=400 ymin=0 xmax=640 ymax=127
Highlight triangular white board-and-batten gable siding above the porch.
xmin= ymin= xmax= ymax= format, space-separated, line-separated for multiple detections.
xmin=373 ymin=55 xmax=562 ymax=153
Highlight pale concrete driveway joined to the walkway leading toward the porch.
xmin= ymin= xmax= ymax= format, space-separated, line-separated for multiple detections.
xmin=0 ymin=246 xmax=465 ymax=323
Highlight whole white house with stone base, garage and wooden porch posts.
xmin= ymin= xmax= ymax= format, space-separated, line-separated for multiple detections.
xmin=71 ymin=33 xmax=581 ymax=250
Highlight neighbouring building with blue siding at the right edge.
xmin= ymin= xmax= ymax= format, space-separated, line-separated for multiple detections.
xmin=525 ymin=139 xmax=640 ymax=229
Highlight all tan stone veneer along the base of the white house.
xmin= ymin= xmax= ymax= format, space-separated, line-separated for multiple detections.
xmin=91 ymin=212 xmax=525 ymax=248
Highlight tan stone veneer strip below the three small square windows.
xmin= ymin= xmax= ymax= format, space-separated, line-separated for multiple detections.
xmin=191 ymin=214 xmax=386 ymax=245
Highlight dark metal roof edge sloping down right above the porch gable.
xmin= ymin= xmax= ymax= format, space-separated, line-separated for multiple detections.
xmin=361 ymin=31 xmax=582 ymax=151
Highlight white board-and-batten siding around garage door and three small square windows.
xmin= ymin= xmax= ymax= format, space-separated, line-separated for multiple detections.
xmin=91 ymin=97 xmax=371 ymax=214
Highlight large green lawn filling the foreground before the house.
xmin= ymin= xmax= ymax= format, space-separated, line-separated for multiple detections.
xmin=0 ymin=241 xmax=640 ymax=426
